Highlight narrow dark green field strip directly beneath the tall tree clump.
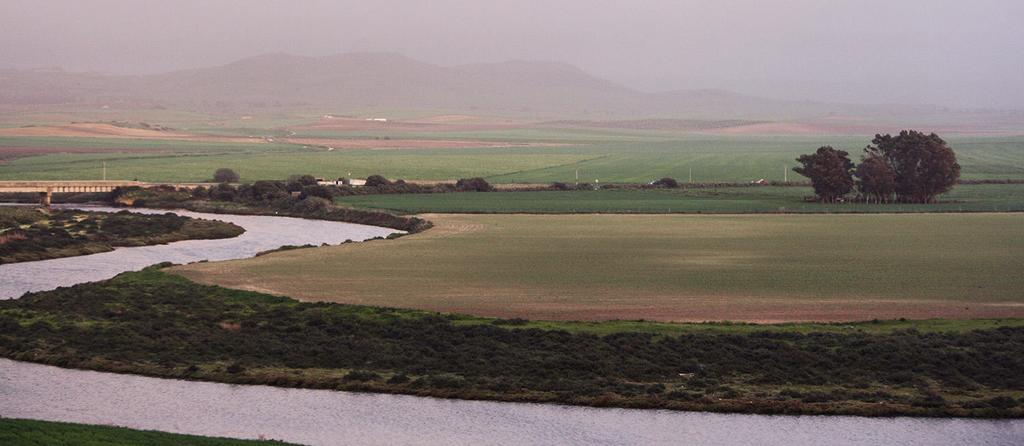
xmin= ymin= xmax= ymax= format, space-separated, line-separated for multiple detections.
xmin=335 ymin=184 xmax=1024 ymax=214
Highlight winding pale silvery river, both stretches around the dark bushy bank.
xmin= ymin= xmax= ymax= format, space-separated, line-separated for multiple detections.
xmin=0 ymin=204 xmax=1024 ymax=446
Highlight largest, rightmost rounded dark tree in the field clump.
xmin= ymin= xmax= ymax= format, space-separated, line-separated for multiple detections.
xmin=864 ymin=130 xmax=959 ymax=203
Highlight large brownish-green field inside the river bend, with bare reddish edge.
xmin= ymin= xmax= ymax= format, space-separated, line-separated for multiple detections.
xmin=174 ymin=214 xmax=1024 ymax=321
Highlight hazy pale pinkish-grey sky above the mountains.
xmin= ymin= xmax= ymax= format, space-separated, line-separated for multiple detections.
xmin=6 ymin=0 xmax=1024 ymax=108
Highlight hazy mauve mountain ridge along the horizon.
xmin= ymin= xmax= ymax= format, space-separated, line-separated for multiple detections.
xmin=0 ymin=52 xmax=966 ymax=120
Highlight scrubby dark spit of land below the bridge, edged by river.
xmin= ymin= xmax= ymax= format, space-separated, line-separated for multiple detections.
xmin=0 ymin=207 xmax=245 ymax=264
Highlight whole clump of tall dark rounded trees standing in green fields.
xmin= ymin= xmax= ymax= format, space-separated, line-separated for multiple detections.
xmin=793 ymin=130 xmax=961 ymax=203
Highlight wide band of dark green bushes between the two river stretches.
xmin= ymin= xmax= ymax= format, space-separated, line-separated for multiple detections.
xmin=0 ymin=269 xmax=1024 ymax=416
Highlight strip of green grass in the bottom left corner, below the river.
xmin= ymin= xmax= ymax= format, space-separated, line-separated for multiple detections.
xmin=0 ymin=418 xmax=296 ymax=446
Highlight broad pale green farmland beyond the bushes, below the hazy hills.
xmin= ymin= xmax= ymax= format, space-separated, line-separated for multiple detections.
xmin=0 ymin=128 xmax=1024 ymax=183
